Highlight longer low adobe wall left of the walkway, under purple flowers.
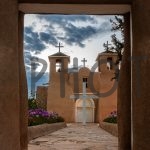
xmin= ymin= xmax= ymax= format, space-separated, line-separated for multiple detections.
xmin=28 ymin=122 xmax=66 ymax=141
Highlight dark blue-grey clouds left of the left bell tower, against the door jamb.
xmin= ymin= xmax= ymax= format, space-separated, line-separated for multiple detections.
xmin=24 ymin=26 xmax=50 ymax=72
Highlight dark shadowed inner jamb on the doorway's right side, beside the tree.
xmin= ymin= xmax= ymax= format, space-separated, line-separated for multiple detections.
xmin=118 ymin=13 xmax=131 ymax=150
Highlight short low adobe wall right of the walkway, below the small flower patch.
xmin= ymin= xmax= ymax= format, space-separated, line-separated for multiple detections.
xmin=99 ymin=122 xmax=118 ymax=136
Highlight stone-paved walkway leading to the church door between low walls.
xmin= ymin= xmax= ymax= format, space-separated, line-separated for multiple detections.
xmin=28 ymin=124 xmax=118 ymax=150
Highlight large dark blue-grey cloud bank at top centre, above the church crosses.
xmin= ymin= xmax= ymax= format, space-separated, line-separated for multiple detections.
xmin=34 ymin=15 xmax=111 ymax=48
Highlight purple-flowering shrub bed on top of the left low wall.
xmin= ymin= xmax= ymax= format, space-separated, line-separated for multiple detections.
xmin=28 ymin=108 xmax=64 ymax=126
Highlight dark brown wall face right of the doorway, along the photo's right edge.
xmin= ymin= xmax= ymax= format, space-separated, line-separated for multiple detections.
xmin=132 ymin=0 xmax=150 ymax=150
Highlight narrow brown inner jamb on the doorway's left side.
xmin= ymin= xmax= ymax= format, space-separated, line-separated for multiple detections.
xmin=18 ymin=12 xmax=28 ymax=150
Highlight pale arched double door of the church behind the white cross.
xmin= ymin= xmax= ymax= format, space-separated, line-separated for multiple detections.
xmin=75 ymin=99 xmax=95 ymax=122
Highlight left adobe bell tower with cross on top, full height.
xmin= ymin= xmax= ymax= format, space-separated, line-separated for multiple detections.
xmin=47 ymin=44 xmax=74 ymax=122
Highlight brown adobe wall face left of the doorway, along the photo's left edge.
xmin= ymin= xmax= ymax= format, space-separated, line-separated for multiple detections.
xmin=0 ymin=0 xmax=21 ymax=150
